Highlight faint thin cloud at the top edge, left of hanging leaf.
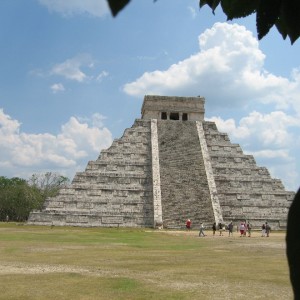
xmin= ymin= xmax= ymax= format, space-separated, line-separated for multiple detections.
xmin=38 ymin=0 xmax=109 ymax=17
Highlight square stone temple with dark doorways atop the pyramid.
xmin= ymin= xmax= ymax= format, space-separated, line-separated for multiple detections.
xmin=142 ymin=96 xmax=205 ymax=122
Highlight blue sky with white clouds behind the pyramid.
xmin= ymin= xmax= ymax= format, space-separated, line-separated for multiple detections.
xmin=0 ymin=0 xmax=300 ymax=190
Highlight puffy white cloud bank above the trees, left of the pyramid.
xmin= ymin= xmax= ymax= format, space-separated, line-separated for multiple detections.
xmin=0 ymin=110 xmax=112 ymax=177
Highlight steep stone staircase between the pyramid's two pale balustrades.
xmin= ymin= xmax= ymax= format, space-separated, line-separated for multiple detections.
xmin=158 ymin=120 xmax=214 ymax=228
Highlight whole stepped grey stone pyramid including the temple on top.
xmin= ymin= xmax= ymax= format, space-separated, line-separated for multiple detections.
xmin=28 ymin=96 xmax=295 ymax=229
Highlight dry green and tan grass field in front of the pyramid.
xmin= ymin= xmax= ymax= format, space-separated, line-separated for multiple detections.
xmin=0 ymin=223 xmax=293 ymax=300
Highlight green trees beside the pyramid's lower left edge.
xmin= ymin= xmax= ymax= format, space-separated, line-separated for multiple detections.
xmin=0 ymin=172 xmax=70 ymax=222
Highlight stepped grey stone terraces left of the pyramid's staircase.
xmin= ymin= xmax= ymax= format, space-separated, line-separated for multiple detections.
xmin=28 ymin=120 xmax=153 ymax=227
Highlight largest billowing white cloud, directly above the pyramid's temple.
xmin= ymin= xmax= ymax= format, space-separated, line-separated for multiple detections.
xmin=123 ymin=23 xmax=300 ymax=114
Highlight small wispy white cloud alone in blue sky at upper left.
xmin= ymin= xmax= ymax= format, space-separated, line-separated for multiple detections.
xmin=50 ymin=54 xmax=94 ymax=82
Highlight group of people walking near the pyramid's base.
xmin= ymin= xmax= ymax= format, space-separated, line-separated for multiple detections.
xmin=186 ymin=219 xmax=271 ymax=237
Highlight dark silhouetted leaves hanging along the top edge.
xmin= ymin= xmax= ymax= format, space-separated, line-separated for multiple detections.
xmin=107 ymin=0 xmax=300 ymax=44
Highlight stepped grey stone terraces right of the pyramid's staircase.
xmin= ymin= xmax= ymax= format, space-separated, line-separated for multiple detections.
xmin=203 ymin=122 xmax=295 ymax=229
